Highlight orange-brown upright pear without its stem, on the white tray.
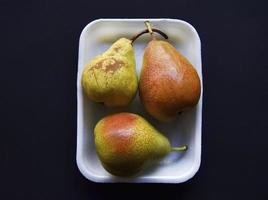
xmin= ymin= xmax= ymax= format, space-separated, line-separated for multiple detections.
xmin=139 ymin=40 xmax=201 ymax=121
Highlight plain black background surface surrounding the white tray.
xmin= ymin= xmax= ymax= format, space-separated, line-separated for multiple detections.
xmin=0 ymin=0 xmax=268 ymax=200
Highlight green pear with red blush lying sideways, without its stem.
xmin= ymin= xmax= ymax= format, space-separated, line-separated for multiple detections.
xmin=94 ymin=113 xmax=171 ymax=176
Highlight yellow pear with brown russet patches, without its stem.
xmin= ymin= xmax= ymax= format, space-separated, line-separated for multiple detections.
xmin=82 ymin=38 xmax=138 ymax=107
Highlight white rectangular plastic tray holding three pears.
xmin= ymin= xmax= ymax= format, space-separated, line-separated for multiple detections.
xmin=77 ymin=19 xmax=203 ymax=183
